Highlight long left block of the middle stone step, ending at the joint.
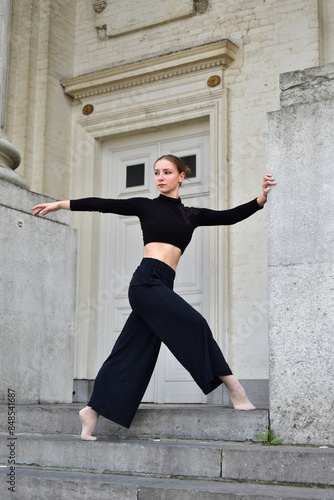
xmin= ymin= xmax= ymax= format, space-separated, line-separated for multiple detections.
xmin=2 ymin=436 xmax=221 ymax=479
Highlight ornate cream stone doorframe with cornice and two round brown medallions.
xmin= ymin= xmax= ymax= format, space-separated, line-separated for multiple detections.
xmin=62 ymin=40 xmax=237 ymax=379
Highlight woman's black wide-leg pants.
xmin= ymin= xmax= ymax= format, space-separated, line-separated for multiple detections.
xmin=88 ymin=258 xmax=232 ymax=427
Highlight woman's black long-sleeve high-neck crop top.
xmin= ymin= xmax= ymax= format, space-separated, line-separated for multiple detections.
xmin=70 ymin=194 xmax=262 ymax=253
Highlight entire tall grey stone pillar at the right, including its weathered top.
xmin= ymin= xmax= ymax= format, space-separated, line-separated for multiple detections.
xmin=268 ymin=63 xmax=334 ymax=445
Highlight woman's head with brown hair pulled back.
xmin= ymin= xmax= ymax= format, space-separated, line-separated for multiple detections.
xmin=154 ymin=158 xmax=185 ymax=198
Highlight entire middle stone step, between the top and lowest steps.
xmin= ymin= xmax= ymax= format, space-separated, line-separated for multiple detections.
xmin=0 ymin=435 xmax=334 ymax=486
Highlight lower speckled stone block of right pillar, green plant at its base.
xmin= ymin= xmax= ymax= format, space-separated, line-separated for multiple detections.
xmin=269 ymin=262 xmax=334 ymax=445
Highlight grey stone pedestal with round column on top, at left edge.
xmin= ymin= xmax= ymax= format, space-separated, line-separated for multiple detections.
xmin=0 ymin=0 xmax=76 ymax=403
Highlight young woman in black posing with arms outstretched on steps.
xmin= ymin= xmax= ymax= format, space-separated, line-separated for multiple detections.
xmin=32 ymin=155 xmax=275 ymax=441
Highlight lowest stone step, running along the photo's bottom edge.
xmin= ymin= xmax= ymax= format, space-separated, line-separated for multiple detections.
xmin=0 ymin=468 xmax=334 ymax=500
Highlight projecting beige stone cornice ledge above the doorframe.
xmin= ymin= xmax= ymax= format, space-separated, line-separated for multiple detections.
xmin=62 ymin=39 xmax=238 ymax=100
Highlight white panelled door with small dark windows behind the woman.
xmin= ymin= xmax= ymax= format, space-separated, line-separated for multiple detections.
xmin=98 ymin=124 xmax=210 ymax=403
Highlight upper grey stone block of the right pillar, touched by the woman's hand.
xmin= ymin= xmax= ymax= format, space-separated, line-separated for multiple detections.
xmin=268 ymin=99 xmax=334 ymax=266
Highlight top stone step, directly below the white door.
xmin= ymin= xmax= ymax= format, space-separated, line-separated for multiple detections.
xmin=0 ymin=403 xmax=268 ymax=441
